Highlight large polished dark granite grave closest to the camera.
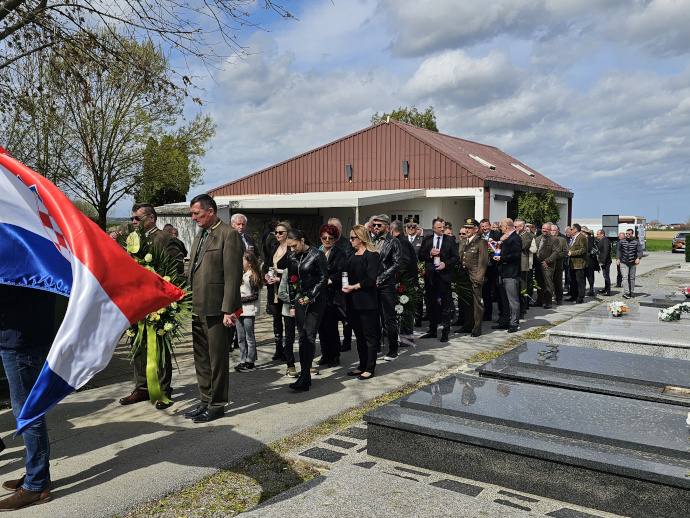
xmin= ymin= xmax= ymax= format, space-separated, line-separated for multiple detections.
xmin=364 ymin=374 xmax=690 ymax=517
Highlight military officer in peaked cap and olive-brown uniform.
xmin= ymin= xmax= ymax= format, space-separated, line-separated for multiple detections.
xmin=456 ymin=218 xmax=489 ymax=337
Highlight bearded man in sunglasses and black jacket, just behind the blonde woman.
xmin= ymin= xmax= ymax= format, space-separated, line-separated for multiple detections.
xmin=371 ymin=214 xmax=403 ymax=361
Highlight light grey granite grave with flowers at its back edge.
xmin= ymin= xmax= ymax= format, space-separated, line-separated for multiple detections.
xmin=546 ymin=304 xmax=690 ymax=360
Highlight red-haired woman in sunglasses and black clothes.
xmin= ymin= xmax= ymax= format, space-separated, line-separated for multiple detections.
xmin=319 ymin=224 xmax=347 ymax=367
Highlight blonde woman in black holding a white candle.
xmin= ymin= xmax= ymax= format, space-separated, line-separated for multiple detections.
xmin=342 ymin=225 xmax=380 ymax=380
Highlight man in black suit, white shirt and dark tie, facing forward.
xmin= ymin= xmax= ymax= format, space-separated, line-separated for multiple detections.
xmin=419 ymin=218 xmax=460 ymax=342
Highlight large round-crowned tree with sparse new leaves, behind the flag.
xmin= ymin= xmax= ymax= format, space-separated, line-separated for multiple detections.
xmin=0 ymin=31 xmax=212 ymax=229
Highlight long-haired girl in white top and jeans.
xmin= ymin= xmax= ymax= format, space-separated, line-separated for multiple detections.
xmin=235 ymin=252 xmax=264 ymax=372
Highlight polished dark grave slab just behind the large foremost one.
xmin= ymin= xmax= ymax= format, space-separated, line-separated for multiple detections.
xmin=477 ymin=341 xmax=690 ymax=407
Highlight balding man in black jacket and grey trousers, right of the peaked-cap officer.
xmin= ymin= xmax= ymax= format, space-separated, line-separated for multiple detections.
xmin=492 ymin=218 xmax=522 ymax=333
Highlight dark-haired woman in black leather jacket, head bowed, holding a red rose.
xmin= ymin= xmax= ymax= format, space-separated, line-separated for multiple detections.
xmin=287 ymin=228 xmax=328 ymax=391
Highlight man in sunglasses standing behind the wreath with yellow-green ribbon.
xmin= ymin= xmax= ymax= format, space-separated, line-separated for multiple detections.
xmin=120 ymin=203 xmax=184 ymax=410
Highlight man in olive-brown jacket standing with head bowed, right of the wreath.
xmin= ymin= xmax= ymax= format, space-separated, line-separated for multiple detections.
xmin=184 ymin=194 xmax=245 ymax=423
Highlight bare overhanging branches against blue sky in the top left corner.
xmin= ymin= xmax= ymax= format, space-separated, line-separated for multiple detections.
xmin=0 ymin=0 xmax=292 ymax=80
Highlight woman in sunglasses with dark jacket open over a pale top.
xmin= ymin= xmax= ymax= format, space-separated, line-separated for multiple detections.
xmin=264 ymin=221 xmax=297 ymax=378
